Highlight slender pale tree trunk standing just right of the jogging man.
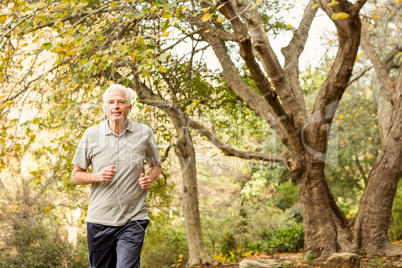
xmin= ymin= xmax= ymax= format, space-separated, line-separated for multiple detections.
xmin=170 ymin=116 xmax=212 ymax=267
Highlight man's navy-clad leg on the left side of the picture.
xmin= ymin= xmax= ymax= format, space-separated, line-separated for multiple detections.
xmin=87 ymin=222 xmax=119 ymax=268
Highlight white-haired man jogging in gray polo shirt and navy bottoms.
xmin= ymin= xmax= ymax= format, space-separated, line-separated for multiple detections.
xmin=72 ymin=85 xmax=161 ymax=268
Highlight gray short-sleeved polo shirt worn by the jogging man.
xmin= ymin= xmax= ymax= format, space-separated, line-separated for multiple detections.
xmin=72 ymin=119 xmax=159 ymax=226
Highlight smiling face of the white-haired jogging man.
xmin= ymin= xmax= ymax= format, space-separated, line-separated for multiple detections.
xmin=105 ymin=90 xmax=133 ymax=122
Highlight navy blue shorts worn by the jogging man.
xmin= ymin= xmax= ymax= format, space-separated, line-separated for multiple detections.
xmin=87 ymin=220 xmax=149 ymax=268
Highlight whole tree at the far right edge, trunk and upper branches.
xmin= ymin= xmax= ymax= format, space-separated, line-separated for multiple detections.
xmin=355 ymin=1 xmax=402 ymax=255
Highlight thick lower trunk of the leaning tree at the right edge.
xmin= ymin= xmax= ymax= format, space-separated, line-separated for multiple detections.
xmin=355 ymin=95 xmax=402 ymax=256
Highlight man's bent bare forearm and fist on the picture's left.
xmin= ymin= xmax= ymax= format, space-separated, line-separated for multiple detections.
xmin=71 ymin=165 xmax=116 ymax=185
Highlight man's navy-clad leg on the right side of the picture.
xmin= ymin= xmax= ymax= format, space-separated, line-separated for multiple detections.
xmin=116 ymin=220 xmax=149 ymax=268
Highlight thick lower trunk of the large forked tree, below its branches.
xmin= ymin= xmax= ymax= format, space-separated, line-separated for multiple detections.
xmin=295 ymin=153 xmax=355 ymax=259
